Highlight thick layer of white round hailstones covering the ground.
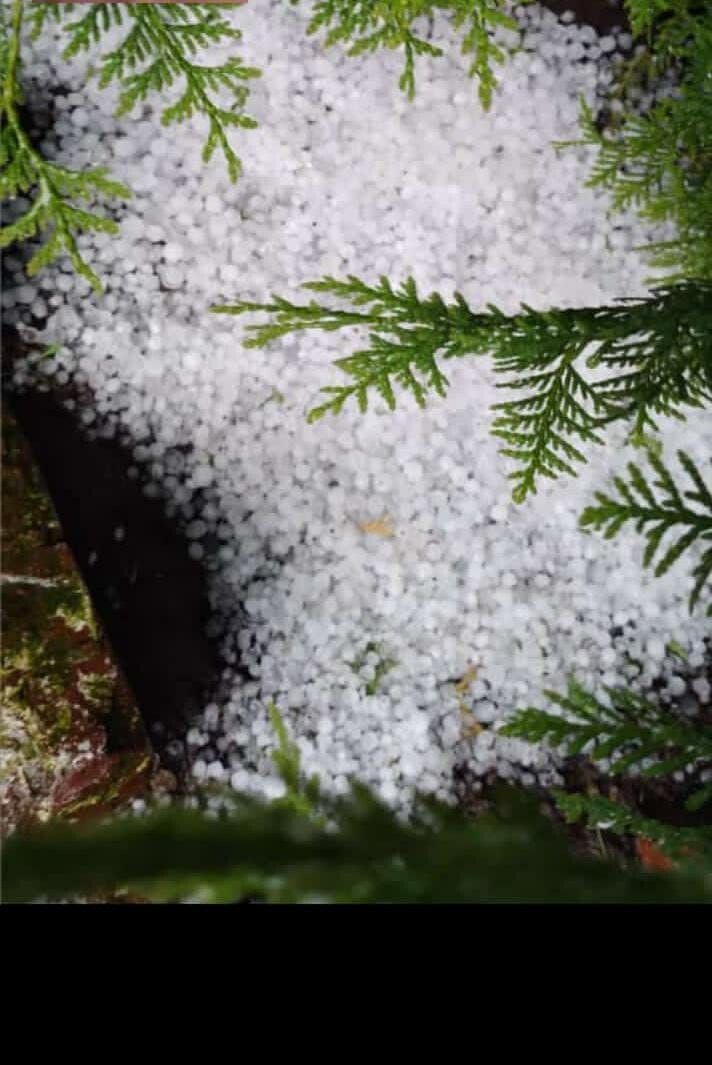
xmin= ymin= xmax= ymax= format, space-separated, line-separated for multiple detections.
xmin=4 ymin=2 xmax=711 ymax=807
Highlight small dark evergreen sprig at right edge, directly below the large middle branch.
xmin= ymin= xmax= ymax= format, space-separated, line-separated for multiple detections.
xmin=581 ymin=449 xmax=712 ymax=613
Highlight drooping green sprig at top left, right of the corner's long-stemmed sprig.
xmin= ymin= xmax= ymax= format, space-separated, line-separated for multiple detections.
xmin=54 ymin=3 xmax=260 ymax=181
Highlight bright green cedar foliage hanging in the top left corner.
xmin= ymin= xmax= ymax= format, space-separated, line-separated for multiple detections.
xmin=0 ymin=0 xmax=255 ymax=292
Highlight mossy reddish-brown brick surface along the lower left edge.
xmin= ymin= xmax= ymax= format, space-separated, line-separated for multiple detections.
xmin=0 ymin=402 xmax=153 ymax=829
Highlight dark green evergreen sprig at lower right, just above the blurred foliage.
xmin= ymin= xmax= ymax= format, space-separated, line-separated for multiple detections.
xmin=501 ymin=679 xmax=712 ymax=809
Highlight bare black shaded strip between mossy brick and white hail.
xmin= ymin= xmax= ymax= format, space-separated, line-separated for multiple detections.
xmin=3 ymin=330 xmax=220 ymax=783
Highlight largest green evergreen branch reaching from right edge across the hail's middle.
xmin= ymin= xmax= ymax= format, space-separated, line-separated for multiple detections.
xmin=212 ymin=277 xmax=712 ymax=502
